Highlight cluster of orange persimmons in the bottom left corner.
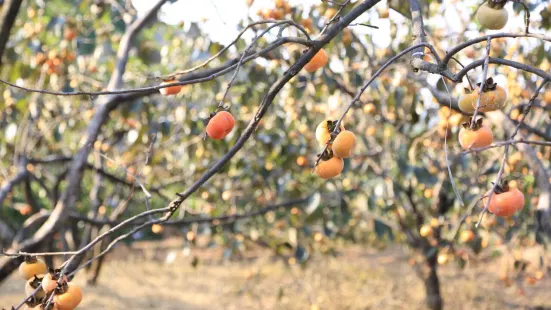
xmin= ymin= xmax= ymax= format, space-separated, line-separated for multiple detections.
xmin=19 ymin=256 xmax=82 ymax=310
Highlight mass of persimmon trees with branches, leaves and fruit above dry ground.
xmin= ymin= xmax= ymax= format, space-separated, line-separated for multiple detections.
xmin=0 ymin=0 xmax=551 ymax=309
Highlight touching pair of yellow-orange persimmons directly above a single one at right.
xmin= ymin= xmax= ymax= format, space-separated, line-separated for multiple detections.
xmin=459 ymin=78 xmax=507 ymax=113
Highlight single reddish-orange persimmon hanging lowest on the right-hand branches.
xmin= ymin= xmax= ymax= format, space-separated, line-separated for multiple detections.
xmin=483 ymin=182 xmax=524 ymax=217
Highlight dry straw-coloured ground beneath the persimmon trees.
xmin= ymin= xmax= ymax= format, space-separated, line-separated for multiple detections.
xmin=0 ymin=242 xmax=551 ymax=310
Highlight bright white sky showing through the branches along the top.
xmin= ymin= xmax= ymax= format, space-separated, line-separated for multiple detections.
xmin=132 ymin=0 xmax=541 ymax=47
